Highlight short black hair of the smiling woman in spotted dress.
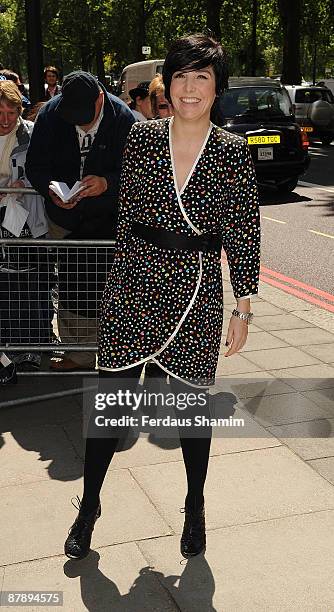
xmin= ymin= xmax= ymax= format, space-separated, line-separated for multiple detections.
xmin=162 ymin=34 xmax=228 ymax=102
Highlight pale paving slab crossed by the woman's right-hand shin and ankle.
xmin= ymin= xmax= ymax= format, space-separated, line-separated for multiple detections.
xmin=131 ymin=446 xmax=334 ymax=533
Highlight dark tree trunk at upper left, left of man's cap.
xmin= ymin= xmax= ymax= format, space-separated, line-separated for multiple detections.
xmin=25 ymin=0 xmax=44 ymax=104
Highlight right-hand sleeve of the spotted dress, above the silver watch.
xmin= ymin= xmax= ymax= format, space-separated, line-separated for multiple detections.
xmin=223 ymin=141 xmax=260 ymax=298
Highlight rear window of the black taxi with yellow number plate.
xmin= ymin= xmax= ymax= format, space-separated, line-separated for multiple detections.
xmin=221 ymin=87 xmax=292 ymax=117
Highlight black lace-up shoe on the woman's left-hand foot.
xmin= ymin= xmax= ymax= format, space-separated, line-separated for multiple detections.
xmin=64 ymin=496 xmax=101 ymax=559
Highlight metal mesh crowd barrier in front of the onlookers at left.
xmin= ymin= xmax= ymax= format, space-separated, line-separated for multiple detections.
xmin=0 ymin=234 xmax=115 ymax=375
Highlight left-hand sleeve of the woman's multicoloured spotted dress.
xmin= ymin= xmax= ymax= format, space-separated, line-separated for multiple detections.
xmin=116 ymin=124 xmax=140 ymax=250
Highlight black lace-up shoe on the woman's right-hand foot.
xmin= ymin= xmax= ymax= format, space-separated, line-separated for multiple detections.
xmin=181 ymin=505 xmax=206 ymax=559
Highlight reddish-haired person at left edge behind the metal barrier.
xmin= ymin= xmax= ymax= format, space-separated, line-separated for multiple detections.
xmin=0 ymin=80 xmax=51 ymax=382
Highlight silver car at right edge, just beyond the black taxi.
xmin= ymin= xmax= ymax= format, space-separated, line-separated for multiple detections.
xmin=285 ymin=85 xmax=334 ymax=145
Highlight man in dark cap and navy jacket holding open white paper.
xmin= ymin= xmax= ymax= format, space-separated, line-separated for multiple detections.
xmin=26 ymin=71 xmax=134 ymax=371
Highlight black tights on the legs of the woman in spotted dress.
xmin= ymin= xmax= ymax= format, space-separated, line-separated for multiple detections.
xmin=82 ymin=365 xmax=211 ymax=513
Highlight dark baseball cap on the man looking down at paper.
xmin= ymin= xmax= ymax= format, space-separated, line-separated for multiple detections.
xmin=55 ymin=70 xmax=100 ymax=125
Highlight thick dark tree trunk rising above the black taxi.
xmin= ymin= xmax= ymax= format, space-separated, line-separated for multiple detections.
xmin=278 ymin=0 xmax=301 ymax=85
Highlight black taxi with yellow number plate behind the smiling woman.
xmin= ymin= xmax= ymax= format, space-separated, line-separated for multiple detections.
xmin=212 ymin=77 xmax=310 ymax=192
